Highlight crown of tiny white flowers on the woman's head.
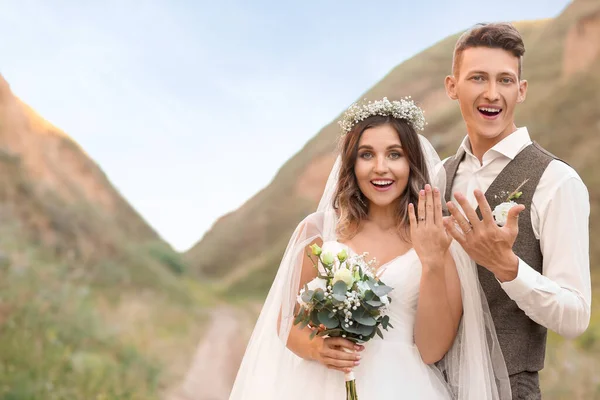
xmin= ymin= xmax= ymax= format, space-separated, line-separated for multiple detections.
xmin=338 ymin=96 xmax=427 ymax=136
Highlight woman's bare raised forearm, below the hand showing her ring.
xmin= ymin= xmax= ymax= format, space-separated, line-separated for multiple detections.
xmin=415 ymin=252 xmax=462 ymax=364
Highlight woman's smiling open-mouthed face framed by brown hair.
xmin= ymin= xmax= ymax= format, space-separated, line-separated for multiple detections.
xmin=354 ymin=124 xmax=410 ymax=207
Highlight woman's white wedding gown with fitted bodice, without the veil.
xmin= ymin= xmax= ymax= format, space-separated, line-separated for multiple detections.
xmin=285 ymin=242 xmax=451 ymax=400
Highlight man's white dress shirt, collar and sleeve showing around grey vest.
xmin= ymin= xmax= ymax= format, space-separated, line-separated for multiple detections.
xmin=451 ymin=127 xmax=592 ymax=338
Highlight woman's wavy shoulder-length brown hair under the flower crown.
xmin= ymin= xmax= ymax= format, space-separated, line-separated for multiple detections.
xmin=333 ymin=115 xmax=430 ymax=240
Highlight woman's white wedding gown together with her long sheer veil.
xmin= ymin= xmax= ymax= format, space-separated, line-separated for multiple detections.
xmin=230 ymin=137 xmax=511 ymax=400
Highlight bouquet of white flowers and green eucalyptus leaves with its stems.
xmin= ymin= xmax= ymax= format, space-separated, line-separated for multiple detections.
xmin=294 ymin=244 xmax=393 ymax=400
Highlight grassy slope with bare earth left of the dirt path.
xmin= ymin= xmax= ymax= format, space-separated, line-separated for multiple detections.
xmin=0 ymin=77 xmax=216 ymax=400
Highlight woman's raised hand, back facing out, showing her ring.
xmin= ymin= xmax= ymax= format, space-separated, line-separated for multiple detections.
xmin=408 ymin=185 xmax=452 ymax=268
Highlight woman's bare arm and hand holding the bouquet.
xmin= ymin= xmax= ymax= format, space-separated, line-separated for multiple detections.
xmin=278 ymin=239 xmax=362 ymax=372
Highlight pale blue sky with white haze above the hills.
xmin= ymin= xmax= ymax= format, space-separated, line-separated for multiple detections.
xmin=0 ymin=0 xmax=570 ymax=250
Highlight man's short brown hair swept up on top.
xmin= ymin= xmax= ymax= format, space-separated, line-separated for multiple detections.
xmin=452 ymin=22 xmax=525 ymax=79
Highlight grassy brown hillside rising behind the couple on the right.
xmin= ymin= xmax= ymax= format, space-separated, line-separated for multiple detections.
xmin=185 ymin=0 xmax=600 ymax=399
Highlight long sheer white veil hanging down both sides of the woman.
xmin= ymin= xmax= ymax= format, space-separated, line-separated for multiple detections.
xmin=230 ymin=135 xmax=512 ymax=400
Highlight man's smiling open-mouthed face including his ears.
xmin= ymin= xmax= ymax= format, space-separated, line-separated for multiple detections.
xmin=446 ymin=47 xmax=527 ymax=142
